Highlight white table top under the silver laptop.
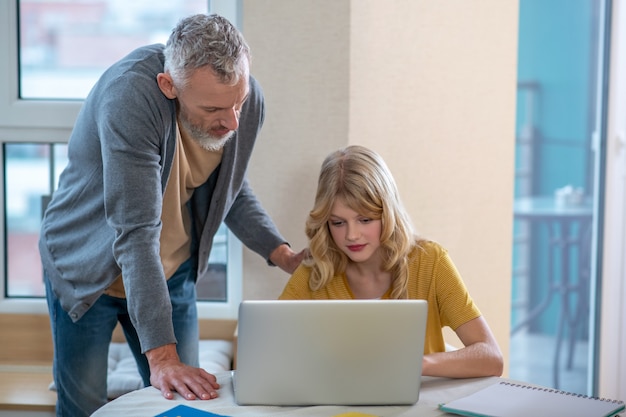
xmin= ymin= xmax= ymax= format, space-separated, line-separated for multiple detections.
xmin=92 ymin=371 xmax=504 ymax=417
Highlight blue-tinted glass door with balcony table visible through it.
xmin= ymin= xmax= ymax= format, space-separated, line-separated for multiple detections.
xmin=510 ymin=0 xmax=608 ymax=395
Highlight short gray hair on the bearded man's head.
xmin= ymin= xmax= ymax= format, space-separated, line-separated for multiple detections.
xmin=163 ymin=14 xmax=250 ymax=88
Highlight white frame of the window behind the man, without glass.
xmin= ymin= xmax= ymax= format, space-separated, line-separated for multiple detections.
xmin=0 ymin=0 xmax=243 ymax=319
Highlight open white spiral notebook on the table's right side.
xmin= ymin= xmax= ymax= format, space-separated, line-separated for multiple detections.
xmin=439 ymin=382 xmax=624 ymax=417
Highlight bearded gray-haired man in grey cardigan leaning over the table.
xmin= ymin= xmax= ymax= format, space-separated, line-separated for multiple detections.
xmin=39 ymin=15 xmax=303 ymax=417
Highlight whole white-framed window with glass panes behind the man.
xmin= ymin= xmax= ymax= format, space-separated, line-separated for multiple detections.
xmin=0 ymin=0 xmax=241 ymax=317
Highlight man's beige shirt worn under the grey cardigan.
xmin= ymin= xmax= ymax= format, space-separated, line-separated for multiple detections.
xmin=105 ymin=126 xmax=222 ymax=298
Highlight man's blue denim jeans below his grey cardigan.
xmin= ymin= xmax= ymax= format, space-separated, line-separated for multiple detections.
xmin=44 ymin=260 xmax=199 ymax=417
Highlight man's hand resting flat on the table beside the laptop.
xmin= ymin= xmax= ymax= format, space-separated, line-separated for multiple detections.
xmin=146 ymin=344 xmax=220 ymax=400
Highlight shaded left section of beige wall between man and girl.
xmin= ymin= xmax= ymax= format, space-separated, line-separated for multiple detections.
xmin=243 ymin=0 xmax=351 ymax=298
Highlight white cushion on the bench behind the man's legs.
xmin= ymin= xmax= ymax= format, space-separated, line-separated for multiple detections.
xmin=50 ymin=340 xmax=233 ymax=399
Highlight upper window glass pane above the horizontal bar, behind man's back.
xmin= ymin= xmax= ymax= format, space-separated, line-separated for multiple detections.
xmin=18 ymin=0 xmax=207 ymax=99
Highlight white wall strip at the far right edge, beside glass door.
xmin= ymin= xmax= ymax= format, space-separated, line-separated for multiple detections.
xmin=599 ymin=0 xmax=626 ymax=400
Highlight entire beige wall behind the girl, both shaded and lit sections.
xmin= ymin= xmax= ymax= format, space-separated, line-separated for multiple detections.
xmin=242 ymin=0 xmax=518 ymax=372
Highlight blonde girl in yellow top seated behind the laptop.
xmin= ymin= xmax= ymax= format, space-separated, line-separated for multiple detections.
xmin=279 ymin=146 xmax=503 ymax=378
